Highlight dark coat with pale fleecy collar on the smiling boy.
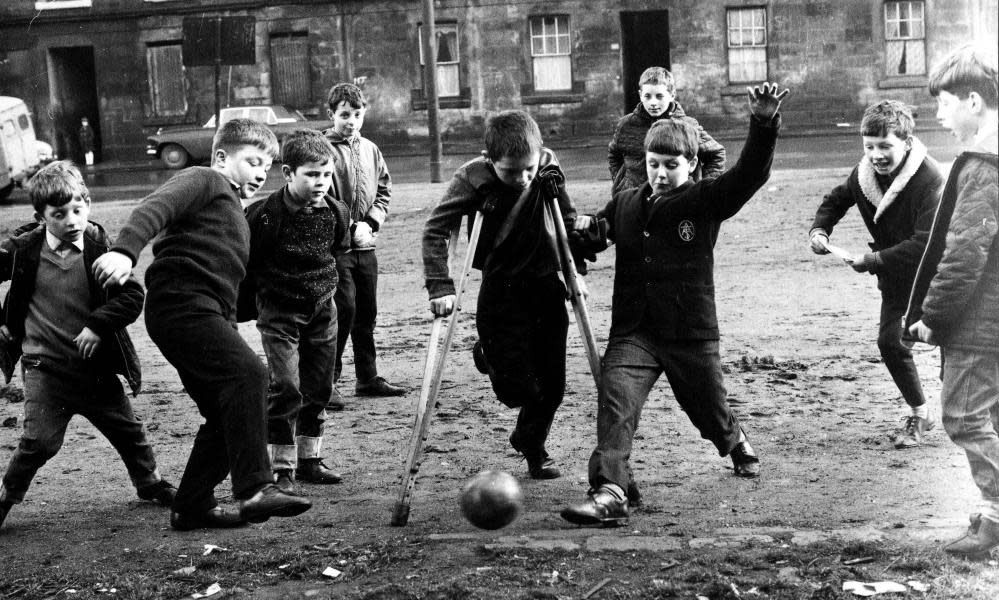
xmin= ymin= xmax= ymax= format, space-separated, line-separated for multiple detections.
xmin=812 ymin=138 xmax=943 ymax=292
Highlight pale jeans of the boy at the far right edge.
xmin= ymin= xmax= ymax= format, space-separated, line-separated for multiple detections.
xmin=940 ymin=347 xmax=999 ymax=505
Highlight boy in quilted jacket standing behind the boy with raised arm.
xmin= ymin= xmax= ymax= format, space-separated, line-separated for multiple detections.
xmin=607 ymin=67 xmax=725 ymax=194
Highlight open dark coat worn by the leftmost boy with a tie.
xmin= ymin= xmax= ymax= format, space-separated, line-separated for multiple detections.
xmin=0 ymin=222 xmax=145 ymax=394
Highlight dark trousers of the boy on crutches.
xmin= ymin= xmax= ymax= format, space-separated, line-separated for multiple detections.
xmin=475 ymin=274 xmax=569 ymax=454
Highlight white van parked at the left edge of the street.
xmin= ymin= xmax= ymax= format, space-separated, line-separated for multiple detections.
xmin=0 ymin=96 xmax=52 ymax=200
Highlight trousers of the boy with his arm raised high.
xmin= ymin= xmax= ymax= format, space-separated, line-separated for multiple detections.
xmin=589 ymin=332 xmax=741 ymax=489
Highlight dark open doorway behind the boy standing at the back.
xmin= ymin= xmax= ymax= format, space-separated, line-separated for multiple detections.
xmin=621 ymin=10 xmax=670 ymax=113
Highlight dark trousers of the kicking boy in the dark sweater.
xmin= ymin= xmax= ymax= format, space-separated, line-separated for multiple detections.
xmin=146 ymin=292 xmax=274 ymax=512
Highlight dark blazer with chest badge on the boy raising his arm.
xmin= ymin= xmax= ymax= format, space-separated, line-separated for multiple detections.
xmin=597 ymin=116 xmax=780 ymax=341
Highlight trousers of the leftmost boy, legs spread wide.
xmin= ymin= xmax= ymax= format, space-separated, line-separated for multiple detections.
xmin=0 ymin=356 xmax=160 ymax=502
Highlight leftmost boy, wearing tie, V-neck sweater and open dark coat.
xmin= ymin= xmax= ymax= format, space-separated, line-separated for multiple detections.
xmin=0 ymin=161 xmax=176 ymax=524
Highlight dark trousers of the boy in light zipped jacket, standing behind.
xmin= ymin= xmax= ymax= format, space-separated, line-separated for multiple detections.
xmin=333 ymin=250 xmax=378 ymax=383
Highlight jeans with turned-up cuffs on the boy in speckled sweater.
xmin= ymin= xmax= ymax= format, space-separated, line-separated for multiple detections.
xmin=257 ymin=297 xmax=336 ymax=469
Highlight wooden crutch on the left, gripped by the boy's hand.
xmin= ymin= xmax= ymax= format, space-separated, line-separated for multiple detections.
xmin=392 ymin=212 xmax=482 ymax=527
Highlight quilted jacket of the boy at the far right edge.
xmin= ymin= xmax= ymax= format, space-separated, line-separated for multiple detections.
xmin=905 ymin=152 xmax=999 ymax=353
